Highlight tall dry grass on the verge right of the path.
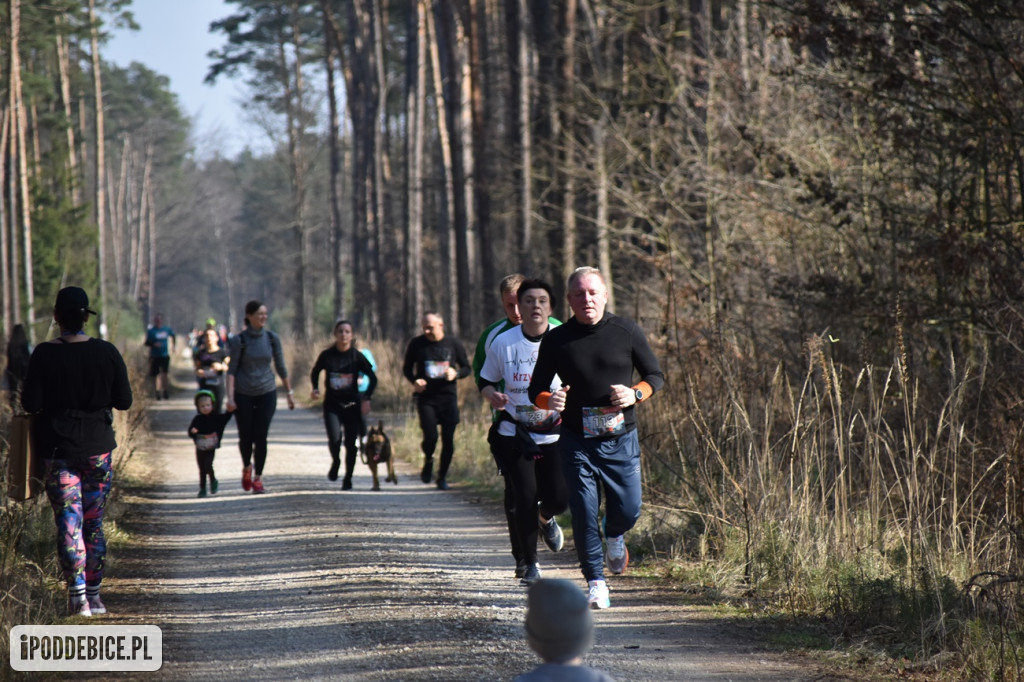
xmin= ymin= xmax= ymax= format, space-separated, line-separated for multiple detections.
xmin=634 ymin=327 xmax=1024 ymax=679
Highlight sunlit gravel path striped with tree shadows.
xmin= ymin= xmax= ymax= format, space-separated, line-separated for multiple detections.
xmin=104 ymin=397 xmax=825 ymax=682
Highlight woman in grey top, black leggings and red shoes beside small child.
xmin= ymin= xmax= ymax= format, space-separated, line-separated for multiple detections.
xmin=226 ymin=301 xmax=295 ymax=495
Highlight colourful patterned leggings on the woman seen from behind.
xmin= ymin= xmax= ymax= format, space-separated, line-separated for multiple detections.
xmin=45 ymin=453 xmax=114 ymax=590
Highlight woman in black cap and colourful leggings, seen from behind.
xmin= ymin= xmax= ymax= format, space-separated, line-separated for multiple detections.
xmin=22 ymin=287 xmax=132 ymax=615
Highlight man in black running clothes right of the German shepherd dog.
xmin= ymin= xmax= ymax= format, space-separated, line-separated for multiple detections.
xmin=401 ymin=312 xmax=471 ymax=491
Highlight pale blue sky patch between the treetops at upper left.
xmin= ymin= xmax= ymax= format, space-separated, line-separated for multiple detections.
xmin=100 ymin=0 xmax=267 ymax=158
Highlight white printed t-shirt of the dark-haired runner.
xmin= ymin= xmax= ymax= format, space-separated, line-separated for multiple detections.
xmin=480 ymin=325 xmax=562 ymax=445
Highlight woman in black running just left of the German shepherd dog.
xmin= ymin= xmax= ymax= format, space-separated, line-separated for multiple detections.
xmin=309 ymin=319 xmax=377 ymax=491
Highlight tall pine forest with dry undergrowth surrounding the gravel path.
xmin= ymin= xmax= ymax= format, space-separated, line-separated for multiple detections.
xmin=0 ymin=0 xmax=1024 ymax=679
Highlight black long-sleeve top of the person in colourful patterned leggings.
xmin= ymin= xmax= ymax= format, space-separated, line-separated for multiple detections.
xmin=22 ymin=339 xmax=132 ymax=460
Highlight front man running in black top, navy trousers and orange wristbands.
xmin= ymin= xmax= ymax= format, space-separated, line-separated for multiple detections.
xmin=528 ymin=267 xmax=665 ymax=608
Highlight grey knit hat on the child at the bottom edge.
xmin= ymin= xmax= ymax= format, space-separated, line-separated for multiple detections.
xmin=526 ymin=579 xmax=594 ymax=663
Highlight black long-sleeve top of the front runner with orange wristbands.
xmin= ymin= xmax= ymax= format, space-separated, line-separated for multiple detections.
xmin=527 ymin=312 xmax=665 ymax=434
